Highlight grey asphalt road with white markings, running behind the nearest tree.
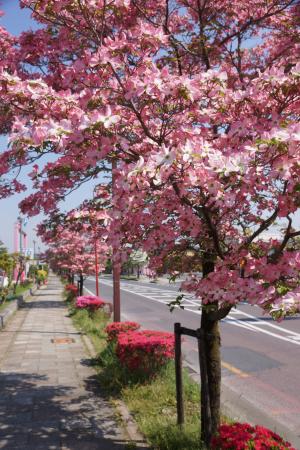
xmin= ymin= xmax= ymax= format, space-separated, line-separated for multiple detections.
xmin=85 ymin=277 xmax=300 ymax=449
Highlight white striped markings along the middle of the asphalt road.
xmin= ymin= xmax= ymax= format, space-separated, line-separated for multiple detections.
xmin=85 ymin=277 xmax=300 ymax=345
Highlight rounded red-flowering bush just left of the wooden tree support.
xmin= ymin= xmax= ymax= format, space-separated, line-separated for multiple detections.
xmin=116 ymin=330 xmax=174 ymax=375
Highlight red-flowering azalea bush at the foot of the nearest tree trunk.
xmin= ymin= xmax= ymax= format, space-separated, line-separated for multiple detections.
xmin=211 ymin=422 xmax=296 ymax=450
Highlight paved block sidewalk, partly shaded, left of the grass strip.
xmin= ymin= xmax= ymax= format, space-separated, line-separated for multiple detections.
xmin=0 ymin=275 xmax=132 ymax=450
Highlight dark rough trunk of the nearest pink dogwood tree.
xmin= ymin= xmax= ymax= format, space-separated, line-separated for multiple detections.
xmin=200 ymin=257 xmax=221 ymax=448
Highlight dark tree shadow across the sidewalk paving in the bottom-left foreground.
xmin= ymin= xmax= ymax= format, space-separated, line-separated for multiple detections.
xmin=0 ymin=372 xmax=137 ymax=450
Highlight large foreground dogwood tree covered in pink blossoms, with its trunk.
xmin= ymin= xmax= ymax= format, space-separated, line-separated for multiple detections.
xmin=0 ymin=0 xmax=300 ymax=443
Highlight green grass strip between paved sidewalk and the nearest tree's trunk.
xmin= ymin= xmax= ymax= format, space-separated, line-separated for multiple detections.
xmin=70 ymin=296 xmax=203 ymax=450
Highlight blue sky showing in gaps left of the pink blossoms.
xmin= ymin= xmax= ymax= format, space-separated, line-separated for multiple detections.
xmin=0 ymin=0 xmax=95 ymax=251
